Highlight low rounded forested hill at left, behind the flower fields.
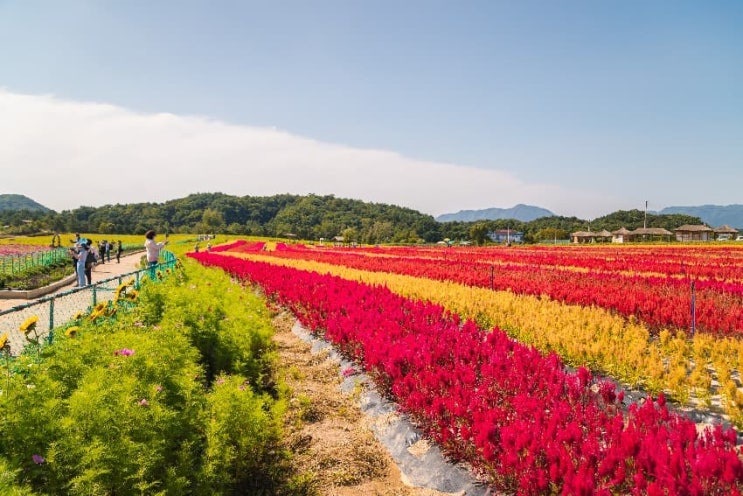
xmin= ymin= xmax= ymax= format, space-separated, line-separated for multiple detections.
xmin=0 ymin=193 xmax=440 ymax=243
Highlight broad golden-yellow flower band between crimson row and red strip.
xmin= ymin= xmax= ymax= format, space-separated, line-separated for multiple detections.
xmin=229 ymin=253 xmax=743 ymax=427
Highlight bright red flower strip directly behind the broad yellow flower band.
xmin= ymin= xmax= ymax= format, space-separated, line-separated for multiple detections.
xmin=238 ymin=241 xmax=743 ymax=336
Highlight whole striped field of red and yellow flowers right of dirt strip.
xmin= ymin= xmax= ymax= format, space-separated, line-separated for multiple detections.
xmin=190 ymin=243 xmax=743 ymax=495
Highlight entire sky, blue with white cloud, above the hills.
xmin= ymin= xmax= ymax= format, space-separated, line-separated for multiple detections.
xmin=0 ymin=0 xmax=743 ymax=219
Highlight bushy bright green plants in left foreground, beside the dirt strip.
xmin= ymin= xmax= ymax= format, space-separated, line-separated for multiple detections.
xmin=0 ymin=263 xmax=296 ymax=495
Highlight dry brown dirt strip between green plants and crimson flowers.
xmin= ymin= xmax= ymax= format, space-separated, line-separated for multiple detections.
xmin=274 ymin=313 xmax=460 ymax=496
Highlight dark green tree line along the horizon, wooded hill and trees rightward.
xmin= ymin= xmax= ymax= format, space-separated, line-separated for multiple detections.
xmin=0 ymin=193 xmax=701 ymax=244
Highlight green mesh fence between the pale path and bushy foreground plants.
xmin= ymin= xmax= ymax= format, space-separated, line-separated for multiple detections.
xmin=0 ymin=252 xmax=177 ymax=356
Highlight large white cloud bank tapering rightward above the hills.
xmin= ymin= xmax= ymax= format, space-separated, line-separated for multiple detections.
xmin=0 ymin=90 xmax=618 ymax=217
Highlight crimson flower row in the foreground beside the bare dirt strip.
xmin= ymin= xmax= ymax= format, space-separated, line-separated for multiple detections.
xmin=190 ymin=253 xmax=743 ymax=495
